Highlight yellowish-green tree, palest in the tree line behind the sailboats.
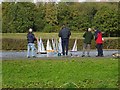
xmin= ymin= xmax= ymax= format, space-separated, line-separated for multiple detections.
xmin=44 ymin=2 xmax=58 ymax=32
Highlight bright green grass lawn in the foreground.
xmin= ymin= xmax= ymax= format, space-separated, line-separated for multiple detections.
xmin=2 ymin=58 xmax=118 ymax=88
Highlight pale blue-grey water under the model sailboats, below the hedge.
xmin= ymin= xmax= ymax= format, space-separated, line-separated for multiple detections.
xmin=0 ymin=50 xmax=118 ymax=60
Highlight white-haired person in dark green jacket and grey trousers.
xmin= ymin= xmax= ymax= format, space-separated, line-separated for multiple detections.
xmin=82 ymin=28 xmax=93 ymax=57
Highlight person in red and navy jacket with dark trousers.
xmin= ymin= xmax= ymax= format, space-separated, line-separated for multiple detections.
xmin=94 ymin=29 xmax=103 ymax=57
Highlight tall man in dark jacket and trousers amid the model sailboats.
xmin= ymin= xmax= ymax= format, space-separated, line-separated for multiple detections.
xmin=58 ymin=25 xmax=71 ymax=56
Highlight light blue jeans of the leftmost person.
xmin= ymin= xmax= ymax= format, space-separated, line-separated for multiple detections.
xmin=27 ymin=43 xmax=36 ymax=57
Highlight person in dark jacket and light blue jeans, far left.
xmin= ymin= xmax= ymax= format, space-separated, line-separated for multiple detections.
xmin=27 ymin=28 xmax=37 ymax=58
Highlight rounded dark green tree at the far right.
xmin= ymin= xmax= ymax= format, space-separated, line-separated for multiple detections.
xmin=94 ymin=2 xmax=118 ymax=36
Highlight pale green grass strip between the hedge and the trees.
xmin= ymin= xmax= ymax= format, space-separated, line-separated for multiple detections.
xmin=2 ymin=32 xmax=83 ymax=39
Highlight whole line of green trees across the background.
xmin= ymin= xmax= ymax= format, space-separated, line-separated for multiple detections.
xmin=2 ymin=2 xmax=119 ymax=36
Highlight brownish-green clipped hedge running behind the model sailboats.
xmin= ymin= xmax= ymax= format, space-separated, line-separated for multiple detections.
xmin=2 ymin=38 xmax=120 ymax=51
